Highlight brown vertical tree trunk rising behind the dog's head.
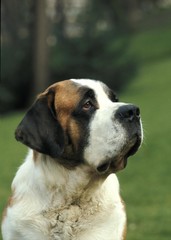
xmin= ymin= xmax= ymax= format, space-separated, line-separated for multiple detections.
xmin=31 ymin=0 xmax=49 ymax=98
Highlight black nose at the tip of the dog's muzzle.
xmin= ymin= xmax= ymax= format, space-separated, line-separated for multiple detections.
xmin=116 ymin=104 xmax=140 ymax=122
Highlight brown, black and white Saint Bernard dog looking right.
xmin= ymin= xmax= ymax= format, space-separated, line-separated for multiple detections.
xmin=2 ymin=79 xmax=143 ymax=240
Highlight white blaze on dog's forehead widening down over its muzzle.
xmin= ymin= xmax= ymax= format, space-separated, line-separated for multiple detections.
xmin=73 ymin=79 xmax=127 ymax=168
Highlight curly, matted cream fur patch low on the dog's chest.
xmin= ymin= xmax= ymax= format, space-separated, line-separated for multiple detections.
xmin=43 ymin=203 xmax=102 ymax=240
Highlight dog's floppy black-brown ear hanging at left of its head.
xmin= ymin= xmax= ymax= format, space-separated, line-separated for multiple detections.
xmin=15 ymin=90 xmax=64 ymax=158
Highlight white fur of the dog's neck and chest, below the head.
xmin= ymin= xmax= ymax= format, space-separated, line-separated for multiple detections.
xmin=2 ymin=150 xmax=126 ymax=240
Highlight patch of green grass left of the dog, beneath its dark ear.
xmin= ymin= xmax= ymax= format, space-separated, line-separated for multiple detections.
xmin=0 ymin=114 xmax=27 ymax=237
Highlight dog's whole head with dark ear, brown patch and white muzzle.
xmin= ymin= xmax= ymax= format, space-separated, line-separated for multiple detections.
xmin=16 ymin=79 xmax=142 ymax=174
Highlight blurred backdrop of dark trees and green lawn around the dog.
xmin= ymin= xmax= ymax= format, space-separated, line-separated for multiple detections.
xmin=0 ymin=0 xmax=171 ymax=240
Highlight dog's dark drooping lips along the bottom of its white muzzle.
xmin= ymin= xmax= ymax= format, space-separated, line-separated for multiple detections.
xmin=97 ymin=136 xmax=141 ymax=174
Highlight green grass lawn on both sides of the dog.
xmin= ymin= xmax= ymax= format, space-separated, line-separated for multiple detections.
xmin=0 ymin=24 xmax=171 ymax=240
